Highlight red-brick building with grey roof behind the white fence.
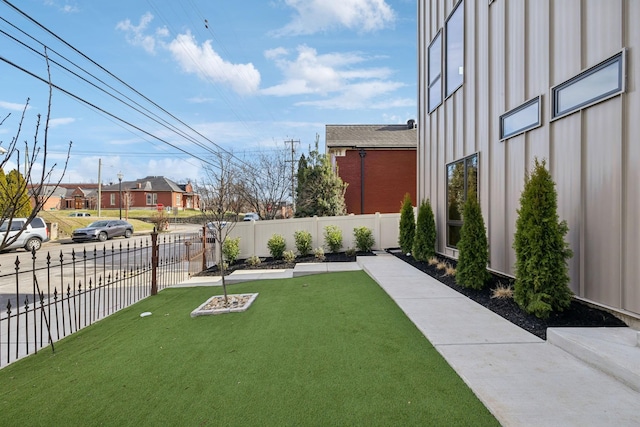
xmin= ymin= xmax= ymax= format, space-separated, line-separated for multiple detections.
xmin=325 ymin=120 xmax=418 ymax=214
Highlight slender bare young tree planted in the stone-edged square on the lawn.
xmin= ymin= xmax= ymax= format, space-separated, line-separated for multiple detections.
xmin=195 ymin=153 xmax=241 ymax=305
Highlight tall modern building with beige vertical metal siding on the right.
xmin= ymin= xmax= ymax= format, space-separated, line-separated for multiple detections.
xmin=417 ymin=0 xmax=640 ymax=317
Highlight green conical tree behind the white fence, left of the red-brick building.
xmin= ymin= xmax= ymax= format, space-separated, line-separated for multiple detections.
xmin=295 ymin=138 xmax=347 ymax=217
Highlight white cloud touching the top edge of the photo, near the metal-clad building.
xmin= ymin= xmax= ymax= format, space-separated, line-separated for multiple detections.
xmin=274 ymin=0 xmax=396 ymax=36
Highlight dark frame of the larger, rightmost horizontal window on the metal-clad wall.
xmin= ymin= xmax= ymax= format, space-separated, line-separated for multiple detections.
xmin=549 ymin=49 xmax=627 ymax=121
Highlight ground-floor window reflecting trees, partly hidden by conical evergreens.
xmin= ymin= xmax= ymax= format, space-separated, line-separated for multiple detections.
xmin=447 ymin=153 xmax=478 ymax=248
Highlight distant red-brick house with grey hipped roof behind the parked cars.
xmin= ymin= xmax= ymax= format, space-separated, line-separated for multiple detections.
xmin=101 ymin=176 xmax=200 ymax=210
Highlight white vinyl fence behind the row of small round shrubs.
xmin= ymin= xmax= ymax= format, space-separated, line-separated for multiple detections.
xmin=222 ymin=213 xmax=400 ymax=258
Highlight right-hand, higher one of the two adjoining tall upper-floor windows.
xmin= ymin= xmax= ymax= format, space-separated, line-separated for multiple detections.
xmin=444 ymin=0 xmax=464 ymax=98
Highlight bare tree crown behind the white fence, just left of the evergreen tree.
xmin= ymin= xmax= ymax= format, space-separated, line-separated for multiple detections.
xmin=238 ymin=149 xmax=291 ymax=219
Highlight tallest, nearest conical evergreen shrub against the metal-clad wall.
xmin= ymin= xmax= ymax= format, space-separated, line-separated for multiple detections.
xmin=513 ymin=158 xmax=573 ymax=319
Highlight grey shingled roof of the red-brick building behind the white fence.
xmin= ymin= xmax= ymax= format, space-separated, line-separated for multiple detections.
xmin=325 ymin=120 xmax=418 ymax=148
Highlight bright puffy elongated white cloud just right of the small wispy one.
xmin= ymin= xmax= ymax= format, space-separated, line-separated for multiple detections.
xmin=167 ymin=32 xmax=260 ymax=95
